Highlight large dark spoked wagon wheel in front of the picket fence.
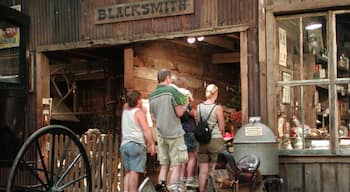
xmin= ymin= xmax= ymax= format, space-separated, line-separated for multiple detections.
xmin=7 ymin=125 xmax=91 ymax=192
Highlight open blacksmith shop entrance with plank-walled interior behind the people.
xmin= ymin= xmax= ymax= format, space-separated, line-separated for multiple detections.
xmin=39 ymin=32 xmax=248 ymax=190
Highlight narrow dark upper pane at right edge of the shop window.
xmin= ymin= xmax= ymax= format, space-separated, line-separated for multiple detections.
xmin=336 ymin=13 xmax=350 ymax=78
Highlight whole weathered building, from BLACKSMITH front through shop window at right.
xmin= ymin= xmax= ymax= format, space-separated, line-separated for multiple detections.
xmin=0 ymin=0 xmax=350 ymax=191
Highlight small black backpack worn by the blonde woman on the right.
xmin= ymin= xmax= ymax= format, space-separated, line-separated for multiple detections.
xmin=194 ymin=105 xmax=216 ymax=144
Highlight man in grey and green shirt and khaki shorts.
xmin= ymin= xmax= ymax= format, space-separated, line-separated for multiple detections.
xmin=149 ymin=69 xmax=188 ymax=190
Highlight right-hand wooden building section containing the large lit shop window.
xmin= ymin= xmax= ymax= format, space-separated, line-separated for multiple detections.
xmin=259 ymin=0 xmax=350 ymax=191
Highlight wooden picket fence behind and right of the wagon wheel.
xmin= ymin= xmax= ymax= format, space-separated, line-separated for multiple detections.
xmin=49 ymin=132 xmax=121 ymax=192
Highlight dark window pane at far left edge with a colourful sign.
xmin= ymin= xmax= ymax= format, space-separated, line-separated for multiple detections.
xmin=0 ymin=21 xmax=20 ymax=82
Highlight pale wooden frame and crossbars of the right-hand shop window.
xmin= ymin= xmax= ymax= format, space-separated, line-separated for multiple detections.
xmin=272 ymin=10 xmax=350 ymax=156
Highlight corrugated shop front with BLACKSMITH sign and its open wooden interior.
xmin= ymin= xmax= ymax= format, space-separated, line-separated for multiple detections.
xmin=0 ymin=0 xmax=260 ymax=189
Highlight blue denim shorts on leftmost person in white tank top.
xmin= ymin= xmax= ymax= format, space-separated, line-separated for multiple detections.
xmin=120 ymin=141 xmax=147 ymax=173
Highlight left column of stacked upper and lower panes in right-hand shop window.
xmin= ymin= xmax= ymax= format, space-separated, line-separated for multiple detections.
xmin=276 ymin=13 xmax=332 ymax=150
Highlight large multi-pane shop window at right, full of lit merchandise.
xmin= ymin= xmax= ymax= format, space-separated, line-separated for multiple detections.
xmin=275 ymin=12 xmax=350 ymax=151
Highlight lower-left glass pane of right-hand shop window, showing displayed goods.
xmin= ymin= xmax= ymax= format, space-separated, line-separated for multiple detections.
xmin=277 ymin=85 xmax=330 ymax=150
